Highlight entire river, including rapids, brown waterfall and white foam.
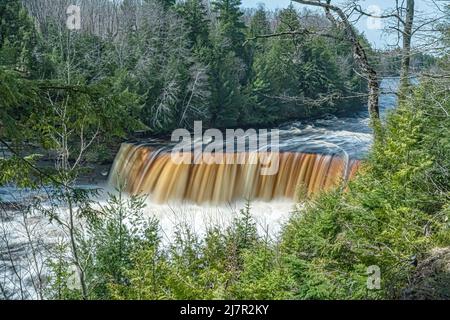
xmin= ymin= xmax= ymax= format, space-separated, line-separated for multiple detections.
xmin=0 ymin=79 xmax=398 ymax=298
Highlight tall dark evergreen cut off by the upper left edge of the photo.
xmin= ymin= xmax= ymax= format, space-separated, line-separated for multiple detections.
xmin=0 ymin=0 xmax=39 ymax=142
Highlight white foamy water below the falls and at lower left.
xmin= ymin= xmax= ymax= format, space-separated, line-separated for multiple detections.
xmin=0 ymin=189 xmax=294 ymax=299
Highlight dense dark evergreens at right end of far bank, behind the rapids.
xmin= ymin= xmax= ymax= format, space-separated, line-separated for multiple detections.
xmin=243 ymin=6 xmax=361 ymax=124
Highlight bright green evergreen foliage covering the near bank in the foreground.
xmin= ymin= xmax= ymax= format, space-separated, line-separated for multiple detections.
xmin=15 ymin=83 xmax=450 ymax=299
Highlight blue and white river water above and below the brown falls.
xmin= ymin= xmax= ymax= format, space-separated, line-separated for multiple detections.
xmin=0 ymin=79 xmax=398 ymax=298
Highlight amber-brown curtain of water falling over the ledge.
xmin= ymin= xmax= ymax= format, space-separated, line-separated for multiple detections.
xmin=109 ymin=143 xmax=359 ymax=204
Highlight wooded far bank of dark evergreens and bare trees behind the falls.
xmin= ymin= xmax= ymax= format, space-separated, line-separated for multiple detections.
xmin=0 ymin=0 xmax=372 ymax=136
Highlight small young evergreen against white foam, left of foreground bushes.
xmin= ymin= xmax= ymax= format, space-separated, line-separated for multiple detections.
xmin=81 ymin=194 xmax=152 ymax=298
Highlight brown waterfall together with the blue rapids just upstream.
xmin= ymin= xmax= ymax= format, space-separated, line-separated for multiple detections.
xmin=109 ymin=79 xmax=398 ymax=204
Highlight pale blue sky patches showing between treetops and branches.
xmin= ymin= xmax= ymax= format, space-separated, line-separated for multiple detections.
xmin=242 ymin=0 xmax=444 ymax=49
